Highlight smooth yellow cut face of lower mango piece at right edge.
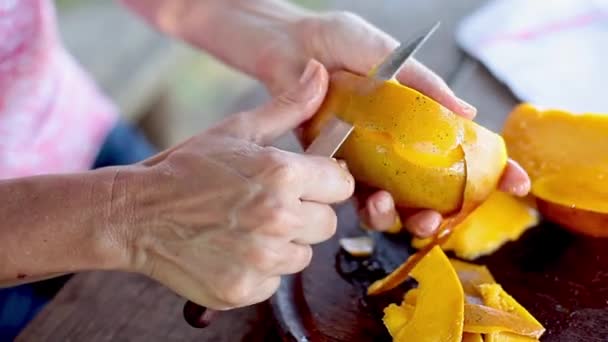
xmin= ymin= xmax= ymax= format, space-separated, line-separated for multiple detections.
xmin=532 ymin=171 xmax=608 ymax=214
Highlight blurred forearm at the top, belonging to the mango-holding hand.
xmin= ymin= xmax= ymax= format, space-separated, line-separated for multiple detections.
xmin=122 ymin=0 xmax=310 ymax=83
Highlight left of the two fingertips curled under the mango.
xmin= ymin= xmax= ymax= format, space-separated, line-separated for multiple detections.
xmin=359 ymin=190 xmax=397 ymax=231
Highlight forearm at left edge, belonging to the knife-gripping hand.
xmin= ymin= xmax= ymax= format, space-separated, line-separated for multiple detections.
xmin=0 ymin=168 xmax=126 ymax=284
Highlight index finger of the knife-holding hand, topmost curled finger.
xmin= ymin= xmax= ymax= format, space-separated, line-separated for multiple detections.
xmin=265 ymin=148 xmax=355 ymax=204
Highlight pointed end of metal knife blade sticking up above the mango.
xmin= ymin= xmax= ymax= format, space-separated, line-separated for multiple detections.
xmin=370 ymin=22 xmax=440 ymax=81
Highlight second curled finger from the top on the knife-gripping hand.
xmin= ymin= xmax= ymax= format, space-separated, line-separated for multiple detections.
xmin=293 ymin=202 xmax=338 ymax=245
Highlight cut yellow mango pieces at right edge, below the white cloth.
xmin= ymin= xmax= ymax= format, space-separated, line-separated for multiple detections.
xmin=503 ymin=104 xmax=608 ymax=237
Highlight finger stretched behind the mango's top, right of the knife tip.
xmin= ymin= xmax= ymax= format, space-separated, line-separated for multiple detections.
xmin=397 ymin=59 xmax=477 ymax=119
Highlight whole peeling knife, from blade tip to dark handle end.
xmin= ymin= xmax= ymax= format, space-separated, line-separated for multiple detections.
xmin=183 ymin=22 xmax=440 ymax=328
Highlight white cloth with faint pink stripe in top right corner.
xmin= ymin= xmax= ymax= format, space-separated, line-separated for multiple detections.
xmin=456 ymin=0 xmax=608 ymax=114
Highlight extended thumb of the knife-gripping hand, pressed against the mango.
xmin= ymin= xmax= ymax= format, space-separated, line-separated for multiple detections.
xmin=240 ymin=60 xmax=328 ymax=145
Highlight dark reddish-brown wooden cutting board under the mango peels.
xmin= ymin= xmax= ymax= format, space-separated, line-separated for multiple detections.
xmin=271 ymin=204 xmax=608 ymax=342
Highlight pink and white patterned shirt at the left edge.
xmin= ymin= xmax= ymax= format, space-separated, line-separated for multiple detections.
xmin=0 ymin=0 xmax=117 ymax=179
